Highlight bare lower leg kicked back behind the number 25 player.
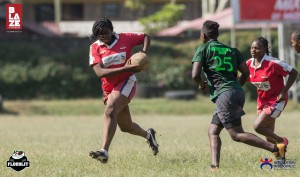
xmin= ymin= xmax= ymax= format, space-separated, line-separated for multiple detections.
xmin=227 ymin=126 xmax=274 ymax=152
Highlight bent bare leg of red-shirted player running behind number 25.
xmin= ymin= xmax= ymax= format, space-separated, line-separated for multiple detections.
xmin=254 ymin=112 xmax=283 ymax=142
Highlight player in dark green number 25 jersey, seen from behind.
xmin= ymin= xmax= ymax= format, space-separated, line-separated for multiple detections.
xmin=192 ymin=21 xmax=286 ymax=170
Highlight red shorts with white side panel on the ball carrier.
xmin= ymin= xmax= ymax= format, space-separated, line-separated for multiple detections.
xmin=103 ymin=75 xmax=136 ymax=104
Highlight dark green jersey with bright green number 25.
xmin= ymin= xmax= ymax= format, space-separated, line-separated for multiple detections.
xmin=192 ymin=40 xmax=245 ymax=102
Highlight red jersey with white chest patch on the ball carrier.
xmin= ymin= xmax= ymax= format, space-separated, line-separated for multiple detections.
xmin=89 ymin=33 xmax=145 ymax=92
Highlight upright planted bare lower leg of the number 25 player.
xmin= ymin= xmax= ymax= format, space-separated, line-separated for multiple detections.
xmin=208 ymin=124 xmax=223 ymax=166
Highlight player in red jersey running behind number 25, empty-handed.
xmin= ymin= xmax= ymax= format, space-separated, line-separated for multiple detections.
xmin=247 ymin=37 xmax=298 ymax=145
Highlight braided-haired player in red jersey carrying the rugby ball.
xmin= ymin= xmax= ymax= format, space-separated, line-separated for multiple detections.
xmin=89 ymin=17 xmax=158 ymax=163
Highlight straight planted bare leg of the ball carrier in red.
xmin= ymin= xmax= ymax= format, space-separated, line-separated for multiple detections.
xmin=102 ymin=91 xmax=128 ymax=151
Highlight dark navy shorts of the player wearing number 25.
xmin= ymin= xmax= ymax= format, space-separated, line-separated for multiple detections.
xmin=211 ymin=89 xmax=245 ymax=129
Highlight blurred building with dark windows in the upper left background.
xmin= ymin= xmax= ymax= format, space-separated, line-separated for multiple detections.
xmin=11 ymin=0 xmax=206 ymax=37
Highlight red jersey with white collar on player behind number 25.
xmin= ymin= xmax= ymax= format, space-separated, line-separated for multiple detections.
xmin=247 ymin=55 xmax=293 ymax=103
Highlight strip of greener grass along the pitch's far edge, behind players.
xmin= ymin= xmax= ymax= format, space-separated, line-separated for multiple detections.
xmin=4 ymin=96 xmax=300 ymax=116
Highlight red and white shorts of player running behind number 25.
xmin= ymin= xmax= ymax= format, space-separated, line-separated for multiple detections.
xmin=257 ymin=100 xmax=287 ymax=118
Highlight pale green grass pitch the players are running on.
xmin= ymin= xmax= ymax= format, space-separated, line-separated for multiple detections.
xmin=0 ymin=99 xmax=300 ymax=177
